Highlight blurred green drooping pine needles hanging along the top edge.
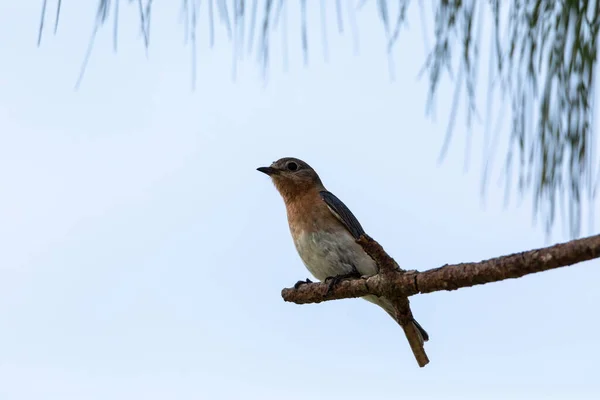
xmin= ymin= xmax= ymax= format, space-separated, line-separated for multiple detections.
xmin=38 ymin=0 xmax=600 ymax=237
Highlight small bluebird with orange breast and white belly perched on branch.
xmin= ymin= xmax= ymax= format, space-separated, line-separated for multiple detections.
xmin=257 ymin=157 xmax=429 ymax=344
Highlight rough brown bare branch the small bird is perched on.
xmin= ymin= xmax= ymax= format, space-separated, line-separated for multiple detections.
xmin=281 ymin=231 xmax=600 ymax=304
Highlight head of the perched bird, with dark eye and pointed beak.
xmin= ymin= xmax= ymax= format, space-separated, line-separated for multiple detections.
xmin=257 ymin=157 xmax=324 ymax=201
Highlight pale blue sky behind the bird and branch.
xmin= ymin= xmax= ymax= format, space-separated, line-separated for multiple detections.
xmin=0 ymin=0 xmax=600 ymax=400
